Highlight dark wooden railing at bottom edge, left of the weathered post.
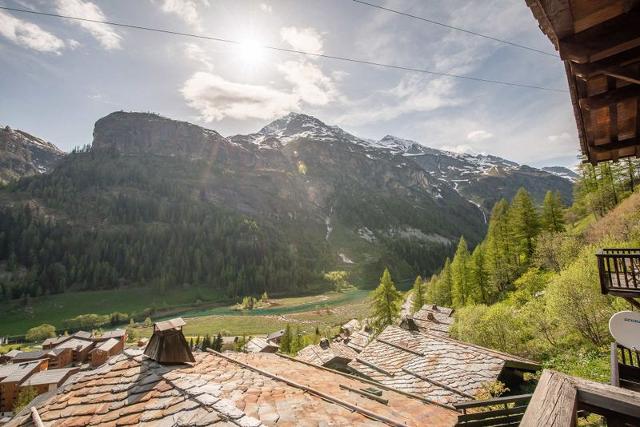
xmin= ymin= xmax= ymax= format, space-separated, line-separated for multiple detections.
xmin=453 ymin=394 xmax=532 ymax=427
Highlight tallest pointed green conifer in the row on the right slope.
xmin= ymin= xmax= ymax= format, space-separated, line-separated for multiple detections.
xmin=509 ymin=188 xmax=540 ymax=263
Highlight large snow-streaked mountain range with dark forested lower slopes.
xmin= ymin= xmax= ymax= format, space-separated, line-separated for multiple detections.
xmin=0 ymin=112 xmax=572 ymax=297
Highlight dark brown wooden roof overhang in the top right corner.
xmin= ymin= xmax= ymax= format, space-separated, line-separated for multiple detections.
xmin=526 ymin=0 xmax=640 ymax=164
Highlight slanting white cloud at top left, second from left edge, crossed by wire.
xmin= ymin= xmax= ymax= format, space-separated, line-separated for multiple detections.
xmin=56 ymin=0 xmax=122 ymax=50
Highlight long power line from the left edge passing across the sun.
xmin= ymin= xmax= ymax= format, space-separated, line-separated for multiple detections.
xmin=0 ymin=6 xmax=567 ymax=93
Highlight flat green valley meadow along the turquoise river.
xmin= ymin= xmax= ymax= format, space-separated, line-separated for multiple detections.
xmin=0 ymin=288 xmax=368 ymax=336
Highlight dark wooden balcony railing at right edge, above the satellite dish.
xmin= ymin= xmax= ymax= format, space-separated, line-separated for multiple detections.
xmin=596 ymin=249 xmax=640 ymax=298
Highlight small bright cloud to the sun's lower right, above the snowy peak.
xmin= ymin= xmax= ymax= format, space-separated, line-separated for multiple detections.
xmin=278 ymin=61 xmax=338 ymax=105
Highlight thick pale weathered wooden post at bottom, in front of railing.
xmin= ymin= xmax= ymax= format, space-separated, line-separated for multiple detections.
xmin=520 ymin=369 xmax=578 ymax=427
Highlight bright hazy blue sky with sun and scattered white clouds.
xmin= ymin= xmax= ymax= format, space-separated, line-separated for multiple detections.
xmin=0 ymin=0 xmax=579 ymax=167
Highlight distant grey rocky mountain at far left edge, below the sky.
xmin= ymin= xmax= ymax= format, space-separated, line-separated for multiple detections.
xmin=0 ymin=126 xmax=64 ymax=183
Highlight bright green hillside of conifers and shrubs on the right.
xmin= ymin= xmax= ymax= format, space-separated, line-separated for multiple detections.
xmin=426 ymin=160 xmax=640 ymax=381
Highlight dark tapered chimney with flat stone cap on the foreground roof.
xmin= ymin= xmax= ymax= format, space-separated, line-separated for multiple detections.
xmin=144 ymin=317 xmax=195 ymax=364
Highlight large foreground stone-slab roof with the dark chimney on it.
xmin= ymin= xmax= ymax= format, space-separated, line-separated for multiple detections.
xmin=8 ymin=350 xmax=457 ymax=427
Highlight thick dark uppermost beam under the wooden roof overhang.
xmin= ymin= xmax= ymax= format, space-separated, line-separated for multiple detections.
xmin=558 ymin=9 xmax=640 ymax=64
